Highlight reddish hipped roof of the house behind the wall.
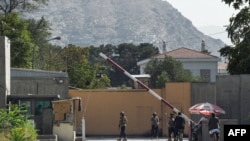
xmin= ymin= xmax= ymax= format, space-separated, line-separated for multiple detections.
xmin=153 ymin=47 xmax=218 ymax=59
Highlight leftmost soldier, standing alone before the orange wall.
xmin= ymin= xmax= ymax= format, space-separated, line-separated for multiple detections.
xmin=118 ymin=111 xmax=128 ymax=141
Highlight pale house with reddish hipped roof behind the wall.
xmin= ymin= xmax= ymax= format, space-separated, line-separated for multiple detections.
xmin=137 ymin=47 xmax=221 ymax=82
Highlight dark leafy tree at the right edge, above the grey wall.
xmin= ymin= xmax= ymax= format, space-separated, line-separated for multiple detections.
xmin=219 ymin=0 xmax=250 ymax=74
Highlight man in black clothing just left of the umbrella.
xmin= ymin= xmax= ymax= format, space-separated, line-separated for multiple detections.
xmin=174 ymin=112 xmax=185 ymax=141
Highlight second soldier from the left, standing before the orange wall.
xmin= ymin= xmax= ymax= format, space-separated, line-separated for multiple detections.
xmin=151 ymin=112 xmax=160 ymax=138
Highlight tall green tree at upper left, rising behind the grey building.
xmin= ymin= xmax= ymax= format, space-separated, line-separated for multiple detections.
xmin=0 ymin=0 xmax=50 ymax=69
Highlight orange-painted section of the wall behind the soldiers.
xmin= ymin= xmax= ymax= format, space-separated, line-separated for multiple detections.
xmin=69 ymin=83 xmax=191 ymax=136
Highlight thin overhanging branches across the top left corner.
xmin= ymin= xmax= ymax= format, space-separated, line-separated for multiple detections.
xmin=0 ymin=0 xmax=49 ymax=14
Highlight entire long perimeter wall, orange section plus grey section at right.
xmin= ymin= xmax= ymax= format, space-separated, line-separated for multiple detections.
xmin=69 ymin=75 xmax=250 ymax=136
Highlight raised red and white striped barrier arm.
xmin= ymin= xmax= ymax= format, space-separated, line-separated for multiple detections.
xmin=99 ymin=53 xmax=194 ymax=123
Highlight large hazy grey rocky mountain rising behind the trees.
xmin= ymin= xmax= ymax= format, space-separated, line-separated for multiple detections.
xmin=24 ymin=0 xmax=224 ymax=56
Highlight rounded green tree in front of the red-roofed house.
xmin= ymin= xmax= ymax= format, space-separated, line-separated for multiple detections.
xmin=145 ymin=56 xmax=199 ymax=88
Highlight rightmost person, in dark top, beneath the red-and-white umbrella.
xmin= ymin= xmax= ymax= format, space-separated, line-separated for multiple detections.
xmin=208 ymin=113 xmax=220 ymax=141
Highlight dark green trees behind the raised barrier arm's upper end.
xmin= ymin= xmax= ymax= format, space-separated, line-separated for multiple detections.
xmin=89 ymin=43 xmax=159 ymax=87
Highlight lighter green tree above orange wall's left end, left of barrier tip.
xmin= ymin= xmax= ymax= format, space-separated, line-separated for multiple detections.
xmin=62 ymin=44 xmax=110 ymax=89
